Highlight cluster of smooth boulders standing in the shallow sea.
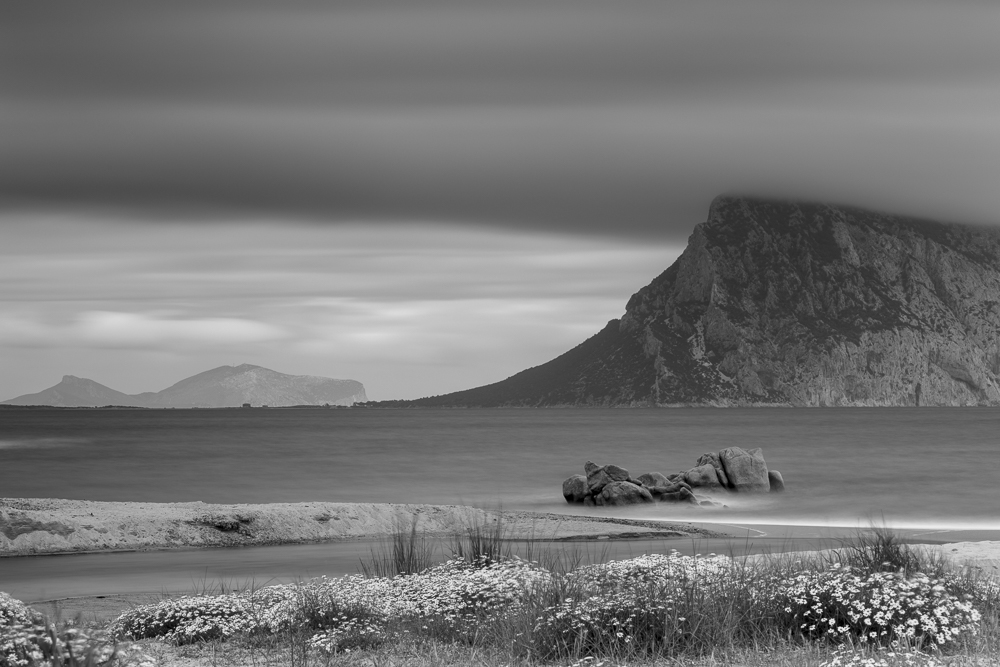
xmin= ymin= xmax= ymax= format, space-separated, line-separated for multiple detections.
xmin=563 ymin=447 xmax=785 ymax=507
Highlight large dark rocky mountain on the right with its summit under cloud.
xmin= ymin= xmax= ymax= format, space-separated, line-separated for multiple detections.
xmin=380 ymin=197 xmax=1000 ymax=407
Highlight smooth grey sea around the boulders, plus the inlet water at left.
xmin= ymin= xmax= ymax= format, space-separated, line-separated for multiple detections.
xmin=0 ymin=407 xmax=1000 ymax=597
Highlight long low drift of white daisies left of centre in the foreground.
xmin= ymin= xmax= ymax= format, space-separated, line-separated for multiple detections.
xmin=111 ymin=559 xmax=548 ymax=651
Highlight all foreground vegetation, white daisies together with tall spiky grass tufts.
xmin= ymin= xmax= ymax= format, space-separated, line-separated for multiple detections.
xmin=0 ymin=523 xmax=1000 ymax=667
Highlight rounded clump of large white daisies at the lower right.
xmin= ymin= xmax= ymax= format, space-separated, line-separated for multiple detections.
xmin=780 ymin=564 xmax=980 ymax=646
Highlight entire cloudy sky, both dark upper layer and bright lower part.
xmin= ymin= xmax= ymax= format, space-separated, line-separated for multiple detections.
xmin=0 ymin=0 xmax=1000 ymax=400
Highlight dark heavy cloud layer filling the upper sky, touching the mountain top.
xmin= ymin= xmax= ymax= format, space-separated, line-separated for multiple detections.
xmin=0 ymin=0 xmax=1000 ymax=242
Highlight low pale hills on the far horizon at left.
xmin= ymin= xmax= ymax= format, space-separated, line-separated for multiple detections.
xmin=3 ymin=364 xmax=367 ymax=408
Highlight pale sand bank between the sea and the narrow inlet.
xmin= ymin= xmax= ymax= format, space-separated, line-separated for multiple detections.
xmin=0 ymin=498 xmax=724 ymax=556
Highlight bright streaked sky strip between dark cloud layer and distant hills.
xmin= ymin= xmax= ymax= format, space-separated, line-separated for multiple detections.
xmin=0 ymin=214 xmax=680 ymax=398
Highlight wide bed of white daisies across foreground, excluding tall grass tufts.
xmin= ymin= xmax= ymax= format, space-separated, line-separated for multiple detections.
xmin=101 ymin=540 xmax=1000 ymax=667
